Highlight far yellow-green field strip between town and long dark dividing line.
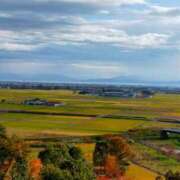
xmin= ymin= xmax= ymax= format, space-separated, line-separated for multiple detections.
xmin=0 ymin=89 xmax=180 ymax=117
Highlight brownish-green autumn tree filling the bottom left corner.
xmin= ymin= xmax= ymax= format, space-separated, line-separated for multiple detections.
xmin=0 ymin=126 xmax=28 ymax=180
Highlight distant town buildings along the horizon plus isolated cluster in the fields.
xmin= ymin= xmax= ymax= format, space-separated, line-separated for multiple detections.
xmin=0 ymin=81 xmax=180 ymax=98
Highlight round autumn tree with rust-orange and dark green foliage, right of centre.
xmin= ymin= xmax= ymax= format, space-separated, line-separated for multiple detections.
xmin=93 ymin=136 xmax=132 ymax=174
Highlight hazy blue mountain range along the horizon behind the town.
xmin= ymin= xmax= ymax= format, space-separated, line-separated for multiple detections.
xmin=0 ymin=73 xmax=180 ymax=86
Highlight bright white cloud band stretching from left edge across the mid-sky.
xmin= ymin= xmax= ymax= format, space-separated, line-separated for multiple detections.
xmin=0 ymin=18 xmax=171 ymax=51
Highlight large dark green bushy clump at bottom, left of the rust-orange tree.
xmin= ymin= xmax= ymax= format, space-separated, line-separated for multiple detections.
xmin=39 ymin=145 xmax=95 ymax=180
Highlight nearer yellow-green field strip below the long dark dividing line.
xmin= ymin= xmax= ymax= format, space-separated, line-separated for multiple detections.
xmin=0 ymin=113 xmax=167 ymax=135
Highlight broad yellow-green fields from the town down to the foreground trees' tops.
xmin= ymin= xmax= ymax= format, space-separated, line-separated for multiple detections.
xmin=0 ymin=89 xmax=180 ymax=135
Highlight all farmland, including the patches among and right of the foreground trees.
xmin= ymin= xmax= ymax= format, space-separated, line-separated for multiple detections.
xmin=0 ymin=89 xmax=180 ymax=180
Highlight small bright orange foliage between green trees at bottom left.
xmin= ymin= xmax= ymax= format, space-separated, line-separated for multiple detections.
xmin=29 ymin=159 xmax=42 ymax=180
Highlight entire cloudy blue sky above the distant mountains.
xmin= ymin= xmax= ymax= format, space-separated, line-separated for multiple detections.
xmin=0 ymin=0 xmax=180 ymax=83
